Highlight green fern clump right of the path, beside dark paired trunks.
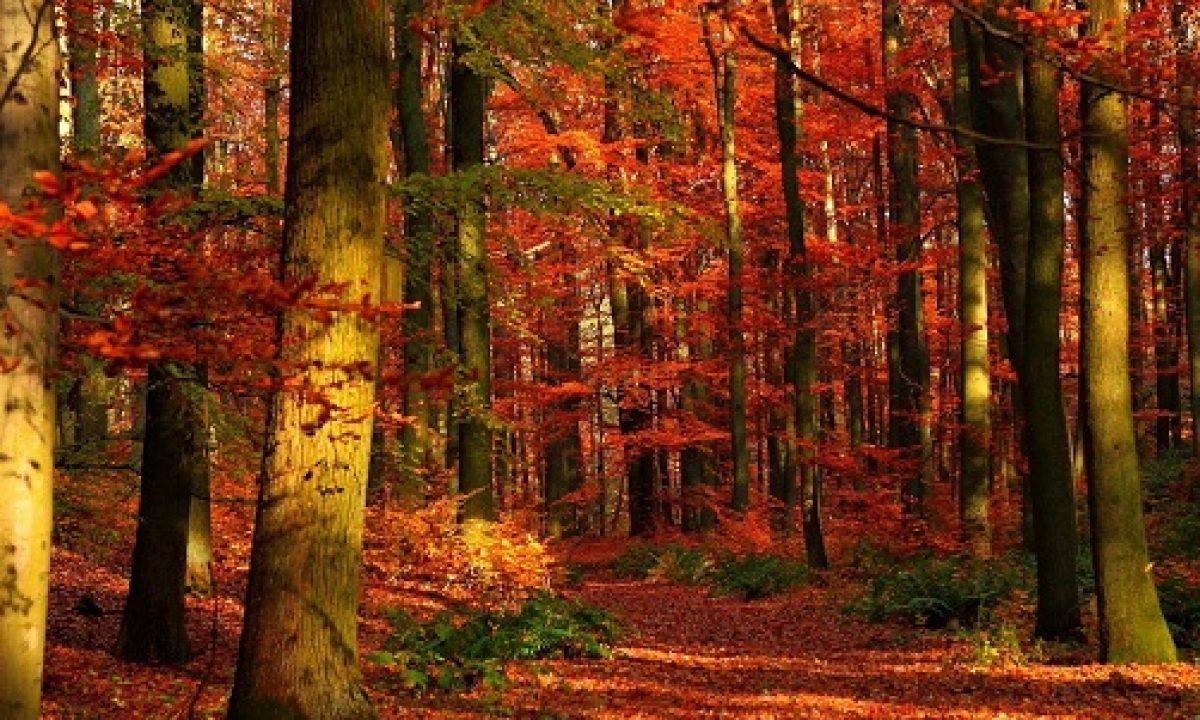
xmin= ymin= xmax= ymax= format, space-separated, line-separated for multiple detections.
xmin=847 ymin=552 xmax=1027 ymax=628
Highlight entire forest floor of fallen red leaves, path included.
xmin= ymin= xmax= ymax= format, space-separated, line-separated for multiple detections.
xmin=44 ymin=463 xmax=1200 ymax=720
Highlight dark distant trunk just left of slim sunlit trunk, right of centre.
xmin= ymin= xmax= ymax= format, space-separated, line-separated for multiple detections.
xmin=883 ymin=0 xmax=932 ymax=516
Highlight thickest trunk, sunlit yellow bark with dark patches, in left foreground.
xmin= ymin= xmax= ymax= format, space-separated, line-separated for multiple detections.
xmin=228 ymin=0 xmax=390 ymax=720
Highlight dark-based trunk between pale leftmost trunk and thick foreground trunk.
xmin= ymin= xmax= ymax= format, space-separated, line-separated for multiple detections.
xmin=116 ymin=0 xmax=209 ymax=664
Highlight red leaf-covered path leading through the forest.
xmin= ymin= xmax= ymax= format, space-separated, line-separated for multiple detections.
xmin=429 ymin=577 xmax=1200 ymax=720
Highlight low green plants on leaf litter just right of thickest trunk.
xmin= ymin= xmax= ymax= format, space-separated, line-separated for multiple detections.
xmin=368 ymin=592 xmax=619 ymax=692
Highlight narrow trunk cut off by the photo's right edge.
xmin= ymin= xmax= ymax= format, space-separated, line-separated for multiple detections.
xmin=1172 ymin=0 xmax=1200 ymax=457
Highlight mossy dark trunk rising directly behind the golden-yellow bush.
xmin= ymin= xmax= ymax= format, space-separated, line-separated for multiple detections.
xmin=450 ymin=42 xmax=496 ymax=521
